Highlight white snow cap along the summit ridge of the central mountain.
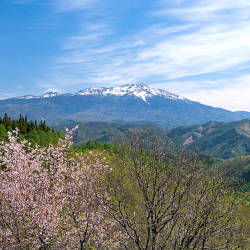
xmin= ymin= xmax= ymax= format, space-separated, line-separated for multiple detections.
xmin=77 ymin=83 xmax=186 ymax=102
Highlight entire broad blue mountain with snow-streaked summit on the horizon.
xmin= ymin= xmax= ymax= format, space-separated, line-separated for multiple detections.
xmin=0 ymin=84 xmax=250 ymax=129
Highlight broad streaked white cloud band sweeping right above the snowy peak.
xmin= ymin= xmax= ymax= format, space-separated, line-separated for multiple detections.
xmin=47 ymin=19 xmax=250 ymax=85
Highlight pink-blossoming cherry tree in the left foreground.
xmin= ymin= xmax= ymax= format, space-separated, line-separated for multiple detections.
xmin=0 ymin=127 xmax=122 ymax=249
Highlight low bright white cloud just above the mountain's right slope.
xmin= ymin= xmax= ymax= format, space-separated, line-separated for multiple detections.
xmin=153 ymin=74 xmax=250 ymax=111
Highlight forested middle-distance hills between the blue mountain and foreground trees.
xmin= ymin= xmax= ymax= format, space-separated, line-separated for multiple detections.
xmin=64 ymin=120 xmax=250 ymax=194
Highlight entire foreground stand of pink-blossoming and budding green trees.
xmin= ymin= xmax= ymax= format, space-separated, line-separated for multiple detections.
xmin=0 ymin=125 xmax=249 ymax=250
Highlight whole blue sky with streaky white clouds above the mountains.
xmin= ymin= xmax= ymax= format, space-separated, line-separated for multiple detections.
xmin=0 ymin=0 xmax=250 ymax=111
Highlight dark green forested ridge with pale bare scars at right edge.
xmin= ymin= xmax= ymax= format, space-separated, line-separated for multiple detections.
xmin=168 ymin=120 xmax=250 ymax=159
